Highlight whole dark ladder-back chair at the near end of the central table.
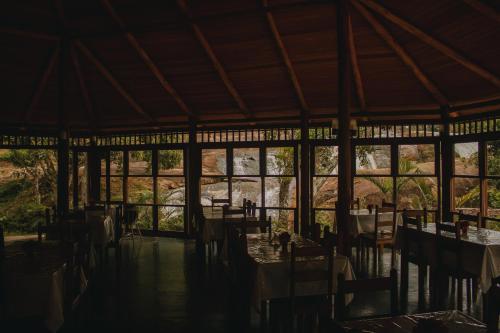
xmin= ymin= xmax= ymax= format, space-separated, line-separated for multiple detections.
xmin=289 ymin=242 xmax=333 ymax=331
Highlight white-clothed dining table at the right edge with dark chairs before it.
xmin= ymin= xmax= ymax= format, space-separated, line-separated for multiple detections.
xmin=396 ymin=222 xmax=500 ymax=294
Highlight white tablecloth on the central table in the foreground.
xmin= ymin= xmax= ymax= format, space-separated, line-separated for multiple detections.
xmin=248 ymin=234 xmax=355 ymax=308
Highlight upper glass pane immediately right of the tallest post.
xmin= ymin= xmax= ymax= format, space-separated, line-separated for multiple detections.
xmin=356 ymin=145 xmax=391 ymax=175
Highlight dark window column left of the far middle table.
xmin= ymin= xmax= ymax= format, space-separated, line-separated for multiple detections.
xmin=185 ymin=121 xmax=201 ymax=236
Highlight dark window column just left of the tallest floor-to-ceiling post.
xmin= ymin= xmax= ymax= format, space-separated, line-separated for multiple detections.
xmin=294 ymin=117 xmax=311 ymax=236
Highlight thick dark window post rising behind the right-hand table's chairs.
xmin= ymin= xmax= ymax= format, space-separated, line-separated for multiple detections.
xmin=441 ymin=107 xmax=454 ymax=221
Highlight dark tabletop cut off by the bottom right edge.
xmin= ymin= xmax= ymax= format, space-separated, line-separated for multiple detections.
xmin=342 ymin=310 xmax=487 ymax=333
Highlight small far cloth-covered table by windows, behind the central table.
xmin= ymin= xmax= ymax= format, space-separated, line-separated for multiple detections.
xmin=202 ymin=206 xmax=258 ymax=244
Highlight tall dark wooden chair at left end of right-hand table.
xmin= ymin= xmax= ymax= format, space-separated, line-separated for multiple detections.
xmin=400 ymin=208 xmax=429 ymax=310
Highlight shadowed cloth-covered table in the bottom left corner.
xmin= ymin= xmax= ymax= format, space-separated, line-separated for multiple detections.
xmin=0 ymin=241 xmax=87 ymax=332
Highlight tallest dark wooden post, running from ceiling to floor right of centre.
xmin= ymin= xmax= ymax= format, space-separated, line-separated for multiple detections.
xmin=336 ymin=0 xmax=352 ymax=255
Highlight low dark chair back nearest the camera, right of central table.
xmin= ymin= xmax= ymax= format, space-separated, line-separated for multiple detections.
xmin=335 ymin=268 xmax=399 ymax=321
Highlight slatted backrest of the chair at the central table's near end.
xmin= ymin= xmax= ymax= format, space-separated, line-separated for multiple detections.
xmin=290 ymin=242 xmax=333 ymax=309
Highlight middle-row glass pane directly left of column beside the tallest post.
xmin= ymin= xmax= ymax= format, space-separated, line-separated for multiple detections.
xmin=264 ymin=177 xmax=296 ymax=208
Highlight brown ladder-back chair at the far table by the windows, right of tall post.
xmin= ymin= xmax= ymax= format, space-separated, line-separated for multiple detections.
xmin=360 ymin=204 xmax=396 ymax=271
